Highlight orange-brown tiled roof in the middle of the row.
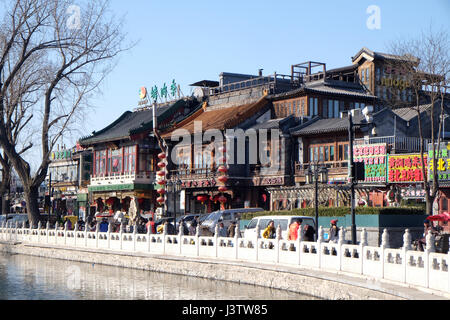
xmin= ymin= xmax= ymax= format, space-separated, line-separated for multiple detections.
xmin=161 ymin=97 xmax=269 ymax=138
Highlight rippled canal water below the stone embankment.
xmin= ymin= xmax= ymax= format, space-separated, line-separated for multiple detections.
xmin=0 ymin=254 xmax=316 ymax=300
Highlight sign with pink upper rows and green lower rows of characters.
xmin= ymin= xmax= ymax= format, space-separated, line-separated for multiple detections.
xmin=353 ymin=143 xmax=387 ymax=183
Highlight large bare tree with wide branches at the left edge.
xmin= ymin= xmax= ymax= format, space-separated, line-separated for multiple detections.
xmin=0 ymin=0 xmax=129 ymax=226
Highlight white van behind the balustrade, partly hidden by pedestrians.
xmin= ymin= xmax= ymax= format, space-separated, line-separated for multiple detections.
xmin=244 ymin=216 xmax=316 ymax=240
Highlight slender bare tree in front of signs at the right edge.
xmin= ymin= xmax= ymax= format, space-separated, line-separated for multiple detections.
xmin=388 ymin=27 xmax=450 ymax=214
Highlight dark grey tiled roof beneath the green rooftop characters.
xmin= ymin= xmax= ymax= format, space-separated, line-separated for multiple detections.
xmin=79 ymin=100 xmax=193 ymax=146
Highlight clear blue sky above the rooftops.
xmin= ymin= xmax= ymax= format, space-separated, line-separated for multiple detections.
xmin=82 ymin=0 xmax=450 ymax=142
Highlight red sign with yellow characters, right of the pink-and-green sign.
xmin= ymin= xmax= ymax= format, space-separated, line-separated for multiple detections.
xmin=388 ymin=154 xmax=427 ymax=183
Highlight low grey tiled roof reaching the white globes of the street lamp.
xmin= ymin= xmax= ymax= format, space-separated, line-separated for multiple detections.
xmin=290 ymin=114 xmax=366 ymax=136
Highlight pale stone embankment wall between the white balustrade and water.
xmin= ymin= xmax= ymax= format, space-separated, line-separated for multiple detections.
xmin=0 ymin=242 xmax=442 ymax=300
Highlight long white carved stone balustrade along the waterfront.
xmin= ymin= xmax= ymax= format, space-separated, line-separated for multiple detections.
xmin=0 ymin=223 xmax=450 ymax=293
